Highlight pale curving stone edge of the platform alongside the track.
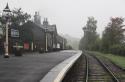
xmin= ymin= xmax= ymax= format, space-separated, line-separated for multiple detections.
xmin=40 ymin=51 xmax=82 ymax=82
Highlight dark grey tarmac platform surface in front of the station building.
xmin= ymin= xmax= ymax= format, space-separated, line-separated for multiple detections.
xmin=0 ymin=51 xmax=77 ymax=82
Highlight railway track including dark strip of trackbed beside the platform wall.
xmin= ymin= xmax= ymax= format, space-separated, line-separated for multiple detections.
xmin=62 ymin=53 xmax=125 ymax=82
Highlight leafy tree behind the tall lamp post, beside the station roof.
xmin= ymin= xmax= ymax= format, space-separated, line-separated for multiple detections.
xmin=0 ymin=8 xmax=31 ymax=34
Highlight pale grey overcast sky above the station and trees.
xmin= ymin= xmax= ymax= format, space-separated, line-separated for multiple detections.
xmin=0 ymin=0 xmax=125 ymax=38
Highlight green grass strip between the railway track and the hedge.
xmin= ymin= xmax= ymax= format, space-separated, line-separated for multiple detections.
xmin=92 ymin=52 xmax=125 ymax=69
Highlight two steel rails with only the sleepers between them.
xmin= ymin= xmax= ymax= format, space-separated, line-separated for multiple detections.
xmin=85 ymin=54 xmax=120 ymax=82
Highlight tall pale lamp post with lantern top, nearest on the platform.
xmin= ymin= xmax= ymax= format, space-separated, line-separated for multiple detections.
xmin=3 ymin=3 xmax=11 ymax=58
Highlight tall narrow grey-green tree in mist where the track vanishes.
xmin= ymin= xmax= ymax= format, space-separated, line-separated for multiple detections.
xmin=79 ymin=17 xmax=98 ymax=50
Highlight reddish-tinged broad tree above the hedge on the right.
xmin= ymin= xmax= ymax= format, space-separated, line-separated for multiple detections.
xmin=102 ymin=17 xmax=125 ymax=51
